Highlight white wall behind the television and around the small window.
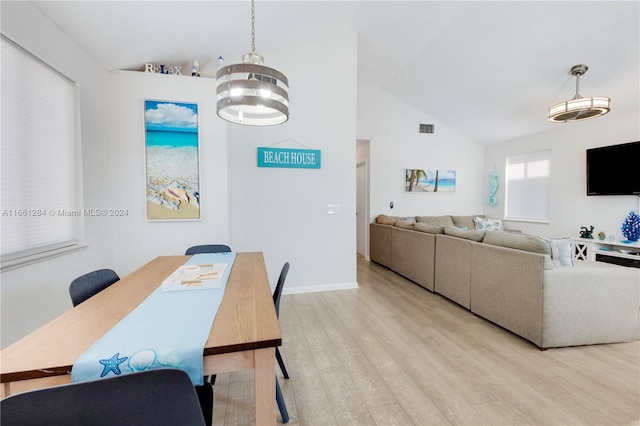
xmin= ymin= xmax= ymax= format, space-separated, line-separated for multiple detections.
xmin=482 ymin=109 xmax=640 ymax=239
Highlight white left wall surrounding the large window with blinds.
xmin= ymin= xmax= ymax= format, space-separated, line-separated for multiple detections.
xmin=0 ymin=2 xmax=114 ymax=347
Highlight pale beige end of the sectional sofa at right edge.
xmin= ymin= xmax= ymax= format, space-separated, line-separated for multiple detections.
xmin=540 ymin=262 xmax=640 ymax=348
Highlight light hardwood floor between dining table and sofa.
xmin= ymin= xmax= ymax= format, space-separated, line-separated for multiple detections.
xmin=214 ymin=257 xmax=640 ymax=425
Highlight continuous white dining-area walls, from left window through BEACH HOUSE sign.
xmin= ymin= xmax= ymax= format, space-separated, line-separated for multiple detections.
xmin=1 ymin=2 xmax=357 ymax=347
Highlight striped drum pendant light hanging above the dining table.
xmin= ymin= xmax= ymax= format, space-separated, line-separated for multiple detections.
xmin=216 ymin=0 xmax=289 ymax=126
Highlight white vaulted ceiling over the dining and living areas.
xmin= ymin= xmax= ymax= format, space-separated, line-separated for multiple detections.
xmin=34 ymin=0 xmax=640 ymax=144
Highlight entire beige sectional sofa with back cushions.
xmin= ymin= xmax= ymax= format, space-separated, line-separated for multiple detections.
xmin=370 ymin=215 xmax=640 ymax=348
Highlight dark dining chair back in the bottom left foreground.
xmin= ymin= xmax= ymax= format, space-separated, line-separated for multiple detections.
xmin=0 ymin=368 xmax=205 ymax=426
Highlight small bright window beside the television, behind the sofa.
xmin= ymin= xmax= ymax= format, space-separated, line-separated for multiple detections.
xmin=505 ymin=149 xmax=551 ymax=222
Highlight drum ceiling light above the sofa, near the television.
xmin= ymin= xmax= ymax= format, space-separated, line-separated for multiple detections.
xmin=549 ymin=65 xmax=611 ymax=123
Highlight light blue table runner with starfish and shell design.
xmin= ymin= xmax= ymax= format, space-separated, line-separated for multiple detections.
xmin=71 ymin=253 xmax=235 ymax=385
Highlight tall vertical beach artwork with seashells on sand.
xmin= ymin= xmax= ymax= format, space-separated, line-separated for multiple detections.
xmin=144 ymin=100 xmax=200 ymax=220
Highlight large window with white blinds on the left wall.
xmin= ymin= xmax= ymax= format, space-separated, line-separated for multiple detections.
xmin=0 ymin=35 xmax=83 ymax=269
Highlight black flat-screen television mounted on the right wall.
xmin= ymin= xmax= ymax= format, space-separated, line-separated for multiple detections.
xmin=587 ymin=141 xmax=640 ymax=195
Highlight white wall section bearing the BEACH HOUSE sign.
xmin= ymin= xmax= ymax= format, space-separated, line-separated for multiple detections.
xmin=228 ymin=28 xmax=357 ymax=293
